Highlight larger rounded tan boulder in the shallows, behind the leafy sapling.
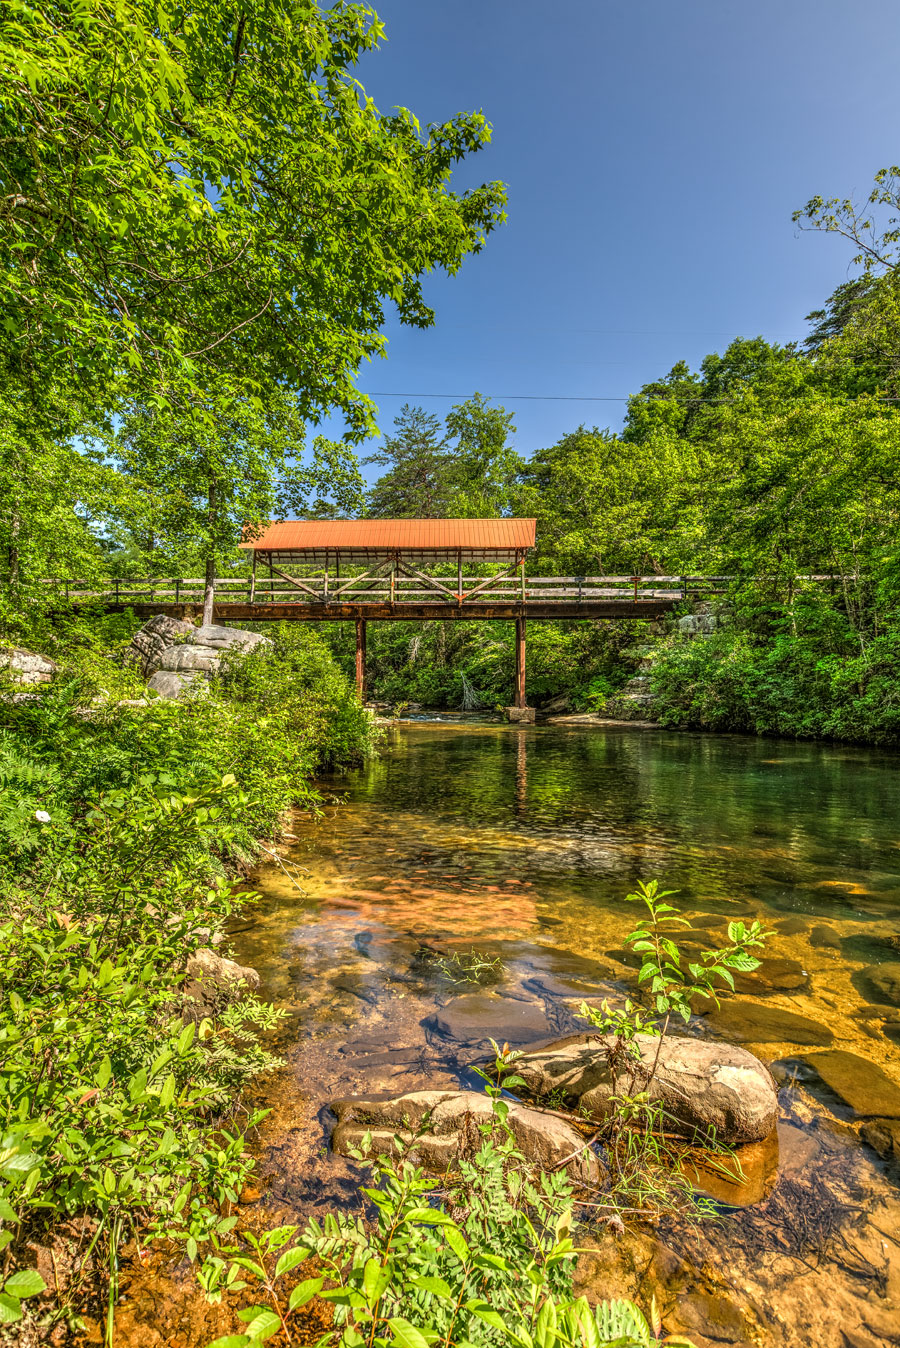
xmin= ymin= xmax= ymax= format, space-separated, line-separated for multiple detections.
xmin=516 ymin=1034 xmax=777 ymax=1146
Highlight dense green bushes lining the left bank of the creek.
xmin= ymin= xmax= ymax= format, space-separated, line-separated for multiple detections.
xmin=0 ymin=630 xmax=373 ymax=1324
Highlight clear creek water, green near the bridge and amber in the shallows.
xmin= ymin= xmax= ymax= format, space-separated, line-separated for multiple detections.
xmin=234 ymin=725 xmax=900 ymax=1348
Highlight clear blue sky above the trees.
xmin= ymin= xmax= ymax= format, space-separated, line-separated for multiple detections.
xmin=317 ymin=0 xmax=900 ymax=454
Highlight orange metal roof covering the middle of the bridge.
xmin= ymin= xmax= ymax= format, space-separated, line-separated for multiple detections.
xmin=240 ymin=519 xmax=535 ymax=553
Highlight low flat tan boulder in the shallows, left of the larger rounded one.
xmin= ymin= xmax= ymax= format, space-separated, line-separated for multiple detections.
xmin=331 ymin=1091 xmax=601 ymax=1184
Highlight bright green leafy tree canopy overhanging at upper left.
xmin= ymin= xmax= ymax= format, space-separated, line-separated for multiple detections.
xmin=0 ymin=0 xmax=504 ymax=434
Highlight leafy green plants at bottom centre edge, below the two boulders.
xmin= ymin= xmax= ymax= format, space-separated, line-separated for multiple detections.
xmin=199 ymin=1091 xmax=684 ymax=1348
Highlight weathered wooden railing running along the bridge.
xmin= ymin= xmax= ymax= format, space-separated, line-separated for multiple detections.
xmin=46 ymin=572 xmax=738 ymax=607
